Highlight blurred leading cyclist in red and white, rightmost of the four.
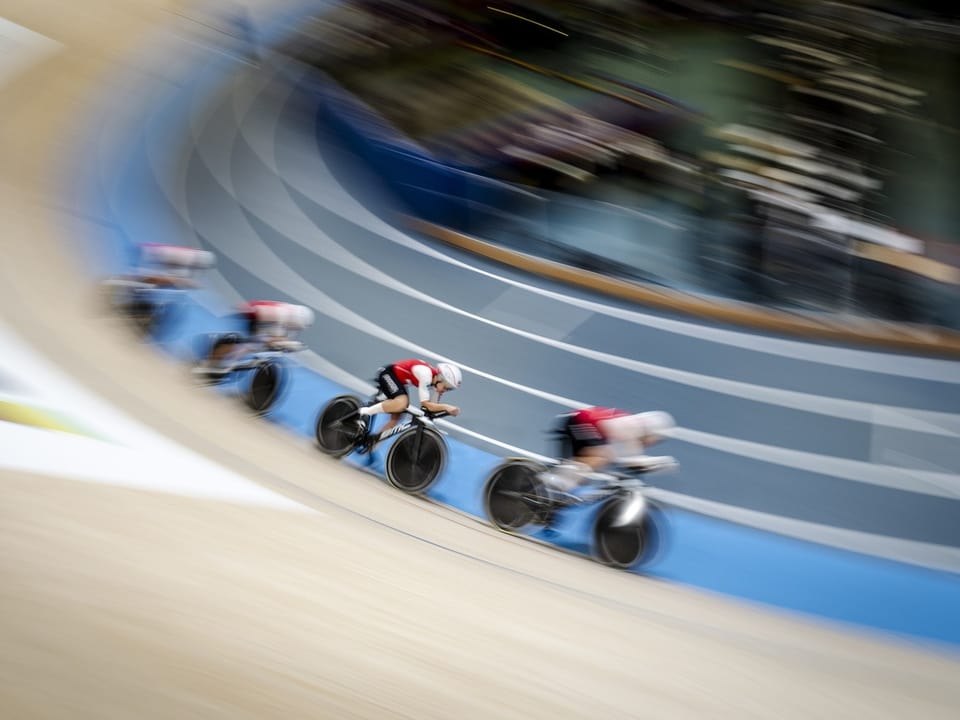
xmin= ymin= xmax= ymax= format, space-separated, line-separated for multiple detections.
xmin=543 ymin=407 xmax=676 ymax=492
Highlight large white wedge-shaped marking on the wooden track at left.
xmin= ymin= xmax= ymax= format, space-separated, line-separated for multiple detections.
xmin=0 ymin=321 xmax=316 ymax=512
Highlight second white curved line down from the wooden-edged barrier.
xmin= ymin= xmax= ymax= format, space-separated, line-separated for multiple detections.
xmin=204 ymin=105 xmax=960 ymax=438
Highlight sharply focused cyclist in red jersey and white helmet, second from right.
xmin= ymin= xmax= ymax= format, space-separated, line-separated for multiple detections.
xmin=357 ymin=358 xmax=463 ymax=450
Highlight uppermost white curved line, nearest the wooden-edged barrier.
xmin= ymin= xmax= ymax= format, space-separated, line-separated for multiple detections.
xmin=248 ymin=70 xmax=960 ymax=384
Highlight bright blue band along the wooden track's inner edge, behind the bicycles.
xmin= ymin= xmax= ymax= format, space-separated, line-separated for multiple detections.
xmin=70 ymin=4 xmax=960 ymax=646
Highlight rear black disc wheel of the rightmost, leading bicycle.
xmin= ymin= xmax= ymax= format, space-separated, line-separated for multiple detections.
xmin=483 ymin=460 xmax=549 ymax=532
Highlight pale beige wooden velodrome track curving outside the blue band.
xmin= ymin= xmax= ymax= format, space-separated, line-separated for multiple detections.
xmin=0 ymin=0 xmax=960 ymax=719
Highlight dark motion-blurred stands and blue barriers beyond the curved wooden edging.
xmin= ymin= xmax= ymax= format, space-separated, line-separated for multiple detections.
xmin=286 ymin=0 xmax=960 ymax=329
